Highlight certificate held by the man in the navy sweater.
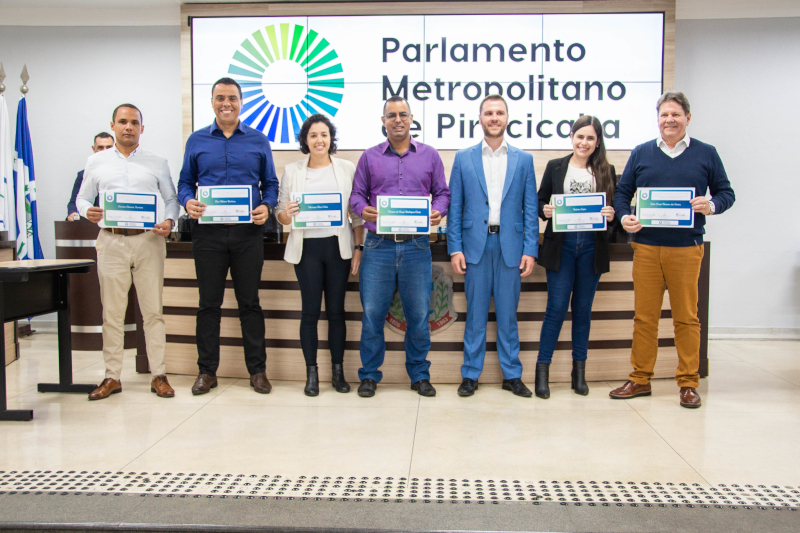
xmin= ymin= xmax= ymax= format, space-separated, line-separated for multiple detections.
xmin=636 ymin=187 xmax=695 ymax=228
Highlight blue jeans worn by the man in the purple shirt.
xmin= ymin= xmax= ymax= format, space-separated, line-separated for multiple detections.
xmin=358 ymin=232 xmax=433 ymax=383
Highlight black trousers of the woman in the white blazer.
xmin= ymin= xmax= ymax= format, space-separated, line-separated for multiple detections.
xmin=294 ymin=237 xmax=350 ymax=366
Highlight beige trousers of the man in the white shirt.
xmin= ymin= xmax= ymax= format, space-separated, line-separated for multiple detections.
xmin=96 ymin=229 xmax=167 ymax=381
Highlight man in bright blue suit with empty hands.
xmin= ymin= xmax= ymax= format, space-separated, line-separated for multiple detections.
xmin=447 ymin=95 xmax=539 ymax=398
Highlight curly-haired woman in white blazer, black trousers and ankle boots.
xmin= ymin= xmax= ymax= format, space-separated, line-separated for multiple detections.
xmin=277 ymin=115 xmax=364 ymax=396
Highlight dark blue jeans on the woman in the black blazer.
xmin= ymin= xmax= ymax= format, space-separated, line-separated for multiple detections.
xmin=536 ymin=231 xmax=600 ymax=365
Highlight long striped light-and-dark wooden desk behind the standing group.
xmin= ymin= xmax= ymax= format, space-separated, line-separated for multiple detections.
xmin=137 ymin=242 xmax=711 ymax=383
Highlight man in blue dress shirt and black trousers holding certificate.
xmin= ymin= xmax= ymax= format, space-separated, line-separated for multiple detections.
xmin=178 ymin=78 xmax=278 ymax=395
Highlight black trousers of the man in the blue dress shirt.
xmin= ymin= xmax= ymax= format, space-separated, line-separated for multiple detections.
xmin=192 ymin=222 xmax=267 ymax=376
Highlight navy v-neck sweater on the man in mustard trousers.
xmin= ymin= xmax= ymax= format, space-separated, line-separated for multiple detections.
xmin=614 ymin=138 xmax=736 ymax=246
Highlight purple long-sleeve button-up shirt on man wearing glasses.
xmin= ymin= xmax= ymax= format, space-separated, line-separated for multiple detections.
xmin=350 ymin=139 xmax=450 ymax=233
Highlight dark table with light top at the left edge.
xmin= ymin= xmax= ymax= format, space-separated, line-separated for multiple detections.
xmin=0 ymin=259 xmax=97 ymax=421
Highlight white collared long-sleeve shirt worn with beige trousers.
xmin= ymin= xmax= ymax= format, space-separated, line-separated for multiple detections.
xmin=76 ymin=146 xmax=181 ymax=222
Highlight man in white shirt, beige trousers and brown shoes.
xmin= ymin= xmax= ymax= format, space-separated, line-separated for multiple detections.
xmin=77 ymin=104 xmax=180 ymax=400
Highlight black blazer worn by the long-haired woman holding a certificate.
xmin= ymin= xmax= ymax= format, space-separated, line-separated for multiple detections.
xmin=539 ymin=154 xmax=616 ymax=274
